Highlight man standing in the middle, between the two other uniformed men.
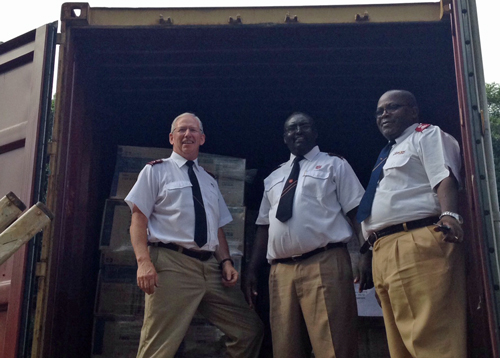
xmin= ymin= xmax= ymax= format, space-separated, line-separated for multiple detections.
xmin=245 ymin=113 xmax=366 ymax=358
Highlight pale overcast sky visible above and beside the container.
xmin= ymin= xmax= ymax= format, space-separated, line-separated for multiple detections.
xmin=0 ymin=0 xmax=500 ymax=83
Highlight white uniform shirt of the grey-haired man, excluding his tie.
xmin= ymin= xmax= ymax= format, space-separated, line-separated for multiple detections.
xmin=125 ymin=152 xmax=232 ymax=251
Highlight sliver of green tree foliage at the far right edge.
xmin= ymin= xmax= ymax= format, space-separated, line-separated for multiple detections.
xmin=486 ymin=82 xmax=500 ymax=197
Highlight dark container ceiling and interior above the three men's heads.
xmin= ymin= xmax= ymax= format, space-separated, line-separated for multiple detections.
xmin=72 ymin=20 xmax=460 ymax=208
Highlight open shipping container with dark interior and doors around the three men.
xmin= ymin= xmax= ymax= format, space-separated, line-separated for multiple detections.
xmin=0 ymin=0 xmax=500 ymax=358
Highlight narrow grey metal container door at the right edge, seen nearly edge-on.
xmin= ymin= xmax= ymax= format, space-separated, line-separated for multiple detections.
xmin=451 ymin=0 xmax=500 ymax=357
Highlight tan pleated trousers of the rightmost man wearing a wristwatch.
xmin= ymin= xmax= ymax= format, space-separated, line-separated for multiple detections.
xmin=373 ymin=226 xmax=467 ymax=358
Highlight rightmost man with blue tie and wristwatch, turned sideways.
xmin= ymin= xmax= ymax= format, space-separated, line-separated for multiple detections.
xmin=358 ymin=90 xmax=467 ymax=358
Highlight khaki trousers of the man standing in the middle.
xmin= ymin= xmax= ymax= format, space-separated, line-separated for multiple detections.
xmin=269 ymin=248 xmax=357 ymax=358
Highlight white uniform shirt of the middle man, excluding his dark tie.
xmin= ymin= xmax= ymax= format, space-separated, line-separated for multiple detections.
xmin=256 ymin=146 xmax=364 ymax=260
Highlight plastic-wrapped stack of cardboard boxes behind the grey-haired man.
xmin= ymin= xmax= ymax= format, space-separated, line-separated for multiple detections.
xmin=92 ymin=146 xmax=246 ymax=358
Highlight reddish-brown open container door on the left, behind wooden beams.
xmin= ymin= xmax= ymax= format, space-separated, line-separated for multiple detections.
xmin=0 ymin=23 xmax=57 ymax=358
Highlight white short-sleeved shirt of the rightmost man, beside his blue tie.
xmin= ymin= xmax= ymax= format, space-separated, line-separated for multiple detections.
xmin=363 ymin=123 xmax=460 ymax=236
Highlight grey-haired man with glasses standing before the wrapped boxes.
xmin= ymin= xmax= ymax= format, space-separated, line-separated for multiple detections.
xmin=125 ymin=113 xmax=263 ymax=358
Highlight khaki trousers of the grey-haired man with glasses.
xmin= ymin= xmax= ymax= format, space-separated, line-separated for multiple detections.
xmin=137 ymin=247 xmax=263 ymax=358
